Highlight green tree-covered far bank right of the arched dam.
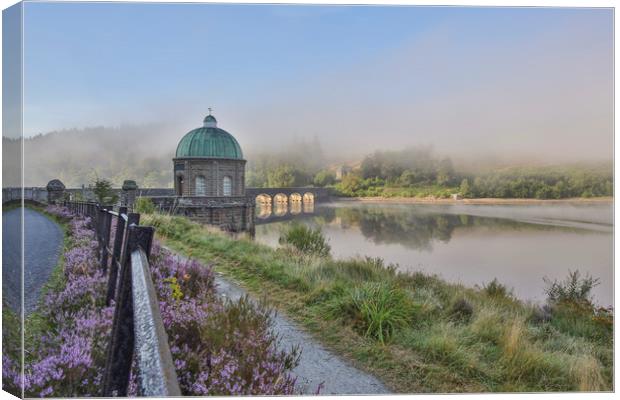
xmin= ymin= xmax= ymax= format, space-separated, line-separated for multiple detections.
xmin=334 ymin=148 xmax=613 ymax=199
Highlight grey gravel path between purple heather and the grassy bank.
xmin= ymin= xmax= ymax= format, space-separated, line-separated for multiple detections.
xmin=163 ymin=248 xmax=390 ymax=394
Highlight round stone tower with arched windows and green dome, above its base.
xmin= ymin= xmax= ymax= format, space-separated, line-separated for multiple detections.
xmin=172 ymin=111 xmax=246 ymax=197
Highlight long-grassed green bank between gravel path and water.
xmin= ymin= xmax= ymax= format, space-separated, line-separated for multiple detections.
xmin=143 ymin=214 xmax=613 ymax=392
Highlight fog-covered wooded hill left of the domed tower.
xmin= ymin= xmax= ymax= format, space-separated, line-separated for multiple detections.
xmin=2 ymin=125 xmax=178 ymax=187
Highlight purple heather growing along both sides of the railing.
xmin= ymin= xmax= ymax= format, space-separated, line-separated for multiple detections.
xmin=3 ymin=206 xmax=299 ymax=397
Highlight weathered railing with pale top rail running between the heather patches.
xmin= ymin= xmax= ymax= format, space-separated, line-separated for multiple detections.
xmin=64 ymin=201 xmax=181 ymax=397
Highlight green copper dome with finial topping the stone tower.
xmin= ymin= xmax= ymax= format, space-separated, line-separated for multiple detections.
xmin=176 ymin=114 xmax=243 ymax=160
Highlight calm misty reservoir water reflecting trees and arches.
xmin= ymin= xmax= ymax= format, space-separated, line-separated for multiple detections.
xmin=256 ymin=202 xmax=613 ymax=305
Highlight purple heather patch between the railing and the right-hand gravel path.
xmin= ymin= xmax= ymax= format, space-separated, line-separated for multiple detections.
xmin=151 ymin=243 xmax=299 ymax=395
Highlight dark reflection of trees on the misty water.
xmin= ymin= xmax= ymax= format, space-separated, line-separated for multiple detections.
xmin=330 ymin=208 xmax=566 ymax=250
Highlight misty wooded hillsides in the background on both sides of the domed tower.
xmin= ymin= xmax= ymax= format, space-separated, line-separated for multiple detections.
xmin=3 ymin=130 xmax=613 ymax=199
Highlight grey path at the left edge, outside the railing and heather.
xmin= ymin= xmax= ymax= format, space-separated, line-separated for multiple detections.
xmin=2 ymin=208 xmax=63 ymax=315
